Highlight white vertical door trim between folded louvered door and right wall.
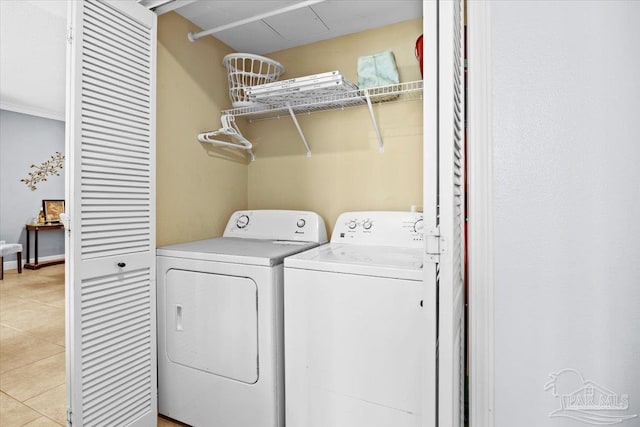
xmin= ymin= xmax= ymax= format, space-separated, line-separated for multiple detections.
xmin=467 ymin=1 xmax=495 ymax=427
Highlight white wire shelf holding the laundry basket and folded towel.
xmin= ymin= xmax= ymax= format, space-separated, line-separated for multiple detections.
xmin=222 ymin=80 xmax=422 ymax=123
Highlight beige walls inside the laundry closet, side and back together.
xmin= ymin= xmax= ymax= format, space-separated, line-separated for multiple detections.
xmin=157 ymin=13 xmax=422 ymax=242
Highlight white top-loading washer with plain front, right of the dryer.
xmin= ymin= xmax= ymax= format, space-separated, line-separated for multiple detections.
xmin=284 ymin=212 xmax=424 ymax=427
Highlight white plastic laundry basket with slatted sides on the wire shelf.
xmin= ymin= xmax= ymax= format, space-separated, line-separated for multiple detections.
xmin=223 ymin=53 xmax=284 ymax=108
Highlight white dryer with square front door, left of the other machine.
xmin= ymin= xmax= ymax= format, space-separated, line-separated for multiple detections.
xmin=157 ymin=210 xmax=327 ymax=427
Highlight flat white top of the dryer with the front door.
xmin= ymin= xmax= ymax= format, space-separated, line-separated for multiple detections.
xmin=156 ymin=237 xmax=318 ymax=266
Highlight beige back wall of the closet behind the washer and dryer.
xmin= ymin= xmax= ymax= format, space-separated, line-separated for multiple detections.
xmin=240 ymin=19 xmax=422 ymax=232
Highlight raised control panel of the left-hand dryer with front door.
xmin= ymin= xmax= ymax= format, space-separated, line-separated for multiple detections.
xmin=223 ymin=210 xmax=327 ymax=243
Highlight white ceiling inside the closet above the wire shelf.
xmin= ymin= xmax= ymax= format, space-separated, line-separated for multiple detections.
xmin=168 ymin=0 xmax=422 ymax=55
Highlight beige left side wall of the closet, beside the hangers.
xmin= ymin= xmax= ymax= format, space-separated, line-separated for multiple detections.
xmin=156 ymin=13 xmax=247 ymax=246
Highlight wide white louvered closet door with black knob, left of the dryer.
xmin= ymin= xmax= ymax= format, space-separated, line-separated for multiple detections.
xmin=67 ymin=0 xmax=157 ymax=426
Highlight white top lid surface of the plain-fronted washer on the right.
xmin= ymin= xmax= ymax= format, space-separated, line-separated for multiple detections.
xmin=284 ymin=243 xmax=423 ymax=280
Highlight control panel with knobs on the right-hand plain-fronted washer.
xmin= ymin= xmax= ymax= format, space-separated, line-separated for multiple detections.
xmin=331 ymin=211 xmax=424 ymax=248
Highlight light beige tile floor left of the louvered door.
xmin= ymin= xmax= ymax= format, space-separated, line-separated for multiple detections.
xmin=0 ymin=265 xmax=188 ymax=427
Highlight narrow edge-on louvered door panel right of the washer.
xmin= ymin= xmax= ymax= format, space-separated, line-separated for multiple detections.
xmin=436 ymin=0 xmax=465 ymax=427
